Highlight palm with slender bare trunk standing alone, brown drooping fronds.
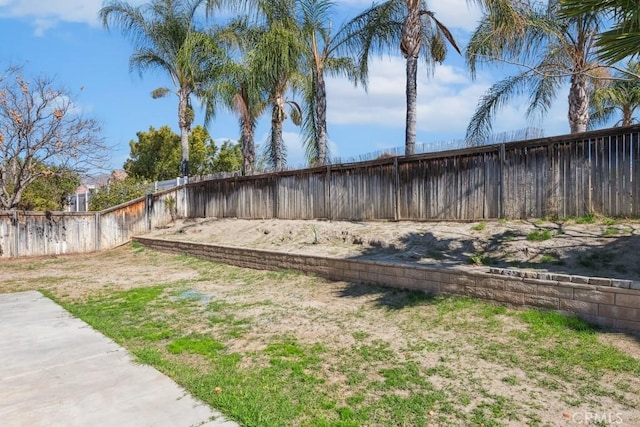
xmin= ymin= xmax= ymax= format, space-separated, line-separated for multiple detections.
xmin=350 ymin=0 xmax=460 ymax=155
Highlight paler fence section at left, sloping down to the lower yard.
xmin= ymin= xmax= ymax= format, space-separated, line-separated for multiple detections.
xmin=0 ymin=187 xmax=185 ymax=258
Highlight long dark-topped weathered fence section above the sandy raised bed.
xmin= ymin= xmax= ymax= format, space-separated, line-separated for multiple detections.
xmin=186 ymin=126 xmax=640 ymax=221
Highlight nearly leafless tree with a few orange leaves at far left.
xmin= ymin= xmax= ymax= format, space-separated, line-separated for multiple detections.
xmin=0 ymin=67 xmax=106 ymax=210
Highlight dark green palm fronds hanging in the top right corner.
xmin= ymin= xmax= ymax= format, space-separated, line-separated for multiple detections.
xmin=562 ymin=0 xmax=640 ymax=64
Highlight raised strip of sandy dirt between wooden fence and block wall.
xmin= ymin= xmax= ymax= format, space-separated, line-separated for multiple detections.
xmin=150 ymin=219 xmax=640 ymax=280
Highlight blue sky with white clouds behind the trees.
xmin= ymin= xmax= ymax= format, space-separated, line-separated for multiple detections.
xmin=0 ymin=0 xmax=569 ymax=174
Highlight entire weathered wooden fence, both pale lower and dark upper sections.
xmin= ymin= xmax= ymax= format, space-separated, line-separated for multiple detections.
xmin=0 ymin=125 xmax=640 ymax=258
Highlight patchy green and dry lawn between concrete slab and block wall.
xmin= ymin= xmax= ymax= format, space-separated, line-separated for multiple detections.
xmin=0 ymin=241 xmax=640 ymax=426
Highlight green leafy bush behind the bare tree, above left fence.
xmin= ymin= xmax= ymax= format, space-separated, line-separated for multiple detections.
xmin=18 ymin=165 xmax=80 ymax=211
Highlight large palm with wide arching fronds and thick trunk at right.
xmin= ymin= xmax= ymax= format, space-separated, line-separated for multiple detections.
xmin=466 ymin=0 xmax=603 ymax=145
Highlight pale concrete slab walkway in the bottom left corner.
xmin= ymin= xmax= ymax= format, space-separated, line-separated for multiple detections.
xmin=0 ymin=292 xmax=237 ymax=427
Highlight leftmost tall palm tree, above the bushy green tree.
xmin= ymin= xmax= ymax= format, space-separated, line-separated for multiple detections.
xmin=99 ymin=0 xmax=221 ymax=176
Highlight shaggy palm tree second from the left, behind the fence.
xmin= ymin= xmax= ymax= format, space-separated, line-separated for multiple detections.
xmin=207 ymin=18 xmax=268 ymax=175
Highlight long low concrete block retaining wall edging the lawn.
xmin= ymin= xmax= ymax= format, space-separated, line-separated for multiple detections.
xmin=133 ymin=237 xmax=640 ymax=334
